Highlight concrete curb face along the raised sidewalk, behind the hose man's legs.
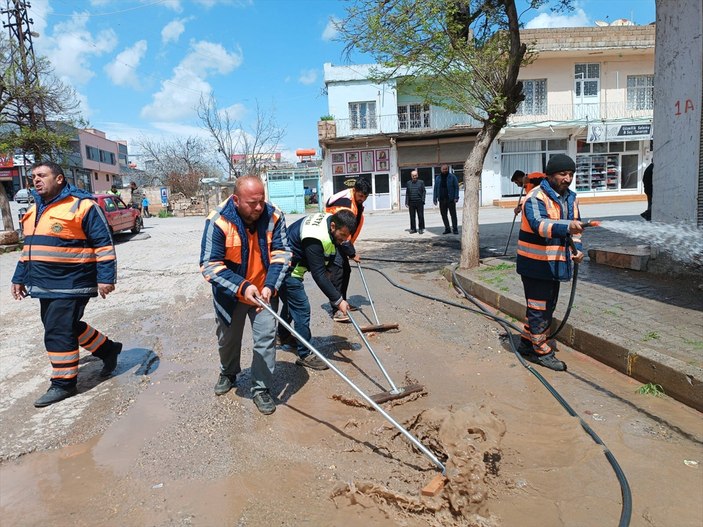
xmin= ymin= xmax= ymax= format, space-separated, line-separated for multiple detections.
xmin=442 ymin=267 xmax=703 ymax=412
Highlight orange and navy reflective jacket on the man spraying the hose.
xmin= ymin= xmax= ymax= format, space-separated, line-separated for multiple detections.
xmin=517 ymin=179 xmax=582 ymax=282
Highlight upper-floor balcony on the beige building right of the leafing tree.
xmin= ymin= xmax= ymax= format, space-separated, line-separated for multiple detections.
xmin=508 ymin=102 xmax=654 ymax=126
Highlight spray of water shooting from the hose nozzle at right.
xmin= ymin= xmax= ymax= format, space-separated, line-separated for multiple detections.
xmin=600 ymin=220 xmax=703 ymax=264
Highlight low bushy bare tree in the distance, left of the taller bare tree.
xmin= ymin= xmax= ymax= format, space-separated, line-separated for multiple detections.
xmin=137 ymin=136 xmax=217 ymax=197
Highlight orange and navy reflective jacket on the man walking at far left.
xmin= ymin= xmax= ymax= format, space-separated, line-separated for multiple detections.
xmin=12 ymin=185 xmax=117 ymax=298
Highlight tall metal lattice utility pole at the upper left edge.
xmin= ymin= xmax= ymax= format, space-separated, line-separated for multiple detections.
xmin=0 ymin=0 xmax=46 ymax=187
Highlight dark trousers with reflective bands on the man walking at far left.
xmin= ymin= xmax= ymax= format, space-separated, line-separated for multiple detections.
xmin=39 ymin=298 xmax=110 ymax=388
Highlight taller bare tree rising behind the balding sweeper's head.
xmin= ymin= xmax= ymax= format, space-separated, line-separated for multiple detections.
xmin=198 ymin=94 xmax=285 ymax=179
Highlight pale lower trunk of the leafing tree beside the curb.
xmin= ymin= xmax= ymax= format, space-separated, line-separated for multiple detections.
xmin=459 ymin=124 xmax=500 ymax=269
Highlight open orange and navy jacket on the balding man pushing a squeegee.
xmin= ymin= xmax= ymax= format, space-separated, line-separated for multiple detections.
xmin=200 ymin=197 xmax=291 ymax=326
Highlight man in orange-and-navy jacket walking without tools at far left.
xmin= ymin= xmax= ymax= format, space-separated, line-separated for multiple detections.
xmin=12 ymin=162 xmax=122 ymax=408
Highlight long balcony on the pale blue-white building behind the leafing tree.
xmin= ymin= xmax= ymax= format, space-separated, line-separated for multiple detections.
xmin=334 ymin=112 xmax=483 ymax=137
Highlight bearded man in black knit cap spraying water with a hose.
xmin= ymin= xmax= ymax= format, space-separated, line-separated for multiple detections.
xmin=517 ymin=154 xmax=583 ymax=371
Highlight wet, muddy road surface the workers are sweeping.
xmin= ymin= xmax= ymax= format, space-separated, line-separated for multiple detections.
xmin=0 ymin=218 xmax=703 ymax=526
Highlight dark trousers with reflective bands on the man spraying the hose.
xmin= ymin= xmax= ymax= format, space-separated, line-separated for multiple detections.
xmin=522 ymin=276 xmax=560 ymax=355
